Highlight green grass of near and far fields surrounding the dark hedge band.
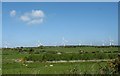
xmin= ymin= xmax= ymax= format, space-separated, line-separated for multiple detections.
xmin=2 ymin=46 xmax=118 ymax=74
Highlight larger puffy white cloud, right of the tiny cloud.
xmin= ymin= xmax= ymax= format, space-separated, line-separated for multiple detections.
xmin=20 ymin=10 xmax=44 ymax=24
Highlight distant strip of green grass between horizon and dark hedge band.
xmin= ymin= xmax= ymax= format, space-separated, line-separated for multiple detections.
xmin=34 ymin=46 xmax=118 ymax=53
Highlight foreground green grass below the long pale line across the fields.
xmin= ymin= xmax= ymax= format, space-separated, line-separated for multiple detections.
xmin=2 ymin=62 xmax=106 ymax=74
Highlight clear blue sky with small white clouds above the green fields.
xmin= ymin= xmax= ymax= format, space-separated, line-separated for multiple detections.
xmin=2 ymin=2 xmax=118 ymax=47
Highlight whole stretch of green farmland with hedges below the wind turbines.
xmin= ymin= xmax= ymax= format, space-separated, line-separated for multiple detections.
xmin=2 ymin=46 xmax=120 ymax=74
